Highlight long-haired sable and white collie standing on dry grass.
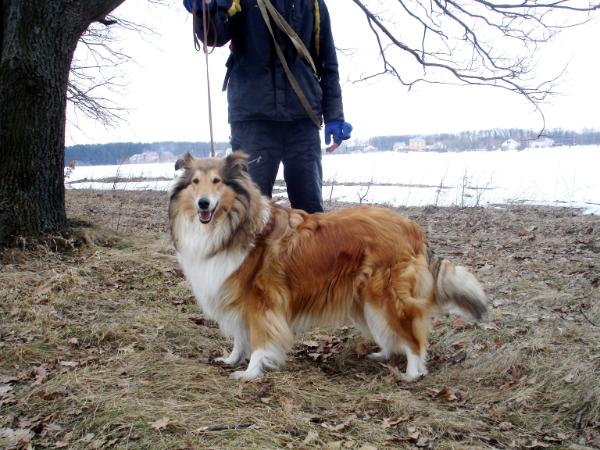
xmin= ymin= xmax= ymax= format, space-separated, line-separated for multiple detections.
xmin=169 ymin=152 xmax=486 ymax=381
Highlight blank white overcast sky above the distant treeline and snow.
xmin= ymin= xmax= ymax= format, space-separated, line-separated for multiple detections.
xmin=66 ymin=0 xmax=600 ymax=145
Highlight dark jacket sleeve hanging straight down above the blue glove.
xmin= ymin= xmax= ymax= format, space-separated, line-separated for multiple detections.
xmin=317 ymin=0 xmax=344 ymax=122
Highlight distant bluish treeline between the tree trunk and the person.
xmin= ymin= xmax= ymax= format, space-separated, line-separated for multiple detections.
xmin=65 ymin=142 xmax=229 ymax=165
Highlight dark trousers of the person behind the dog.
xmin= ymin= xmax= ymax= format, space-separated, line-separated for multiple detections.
xmin=231 ymin=119 xmax=323 ymax=213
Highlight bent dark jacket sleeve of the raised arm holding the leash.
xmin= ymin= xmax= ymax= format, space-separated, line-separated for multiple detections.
xmin=194 ymin=0 xmax=241 ymax=47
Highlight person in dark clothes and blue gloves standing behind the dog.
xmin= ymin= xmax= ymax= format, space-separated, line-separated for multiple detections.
xmin=183 ymin=0 xmax=352 ymax=213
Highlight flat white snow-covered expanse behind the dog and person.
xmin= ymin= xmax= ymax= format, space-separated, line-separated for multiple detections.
xmin=67 ymin=146 xmax=600 ymax=214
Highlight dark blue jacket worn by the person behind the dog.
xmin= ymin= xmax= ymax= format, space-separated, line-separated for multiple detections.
xmin=196 ymin=0 xmax=344 ymax=122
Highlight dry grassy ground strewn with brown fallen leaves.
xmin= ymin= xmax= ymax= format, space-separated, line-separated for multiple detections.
xmin=0 ymin=191 xmax=600 ymax=449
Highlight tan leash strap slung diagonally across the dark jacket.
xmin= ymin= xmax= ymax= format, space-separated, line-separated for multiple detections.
xmin=257 ymin=0 xmax=321 ymax=129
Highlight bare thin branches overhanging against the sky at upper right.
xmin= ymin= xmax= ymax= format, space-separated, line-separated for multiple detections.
xmin=353 ymin=0 xmax=600 ymax=111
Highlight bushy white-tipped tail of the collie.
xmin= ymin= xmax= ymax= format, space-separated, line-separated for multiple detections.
xmin=427 ymin=248 xmax=487 ymax=320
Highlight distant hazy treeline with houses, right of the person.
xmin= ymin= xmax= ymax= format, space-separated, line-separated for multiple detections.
xmin=360 ymin=128 xmax=600 ymax=151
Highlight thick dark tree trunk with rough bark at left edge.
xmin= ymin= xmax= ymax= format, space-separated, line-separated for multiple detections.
xmin=0 ymin=0 xmax=123 ymax=245
